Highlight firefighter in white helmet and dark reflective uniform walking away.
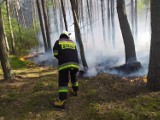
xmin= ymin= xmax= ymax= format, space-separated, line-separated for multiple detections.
xmin=53 ymin=31 xmax=79 ymax=108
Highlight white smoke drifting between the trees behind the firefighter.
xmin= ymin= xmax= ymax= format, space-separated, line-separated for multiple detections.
xmin=31 ymin=0 xmax=151 ymax=76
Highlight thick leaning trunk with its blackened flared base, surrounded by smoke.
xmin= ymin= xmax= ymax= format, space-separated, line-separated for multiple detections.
xmin=111 ymin=0 xmax=142 ymax=74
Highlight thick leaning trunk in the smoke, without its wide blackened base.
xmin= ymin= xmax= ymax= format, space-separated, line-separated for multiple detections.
xmin=117 ymin=0 xmax=137 ymax=63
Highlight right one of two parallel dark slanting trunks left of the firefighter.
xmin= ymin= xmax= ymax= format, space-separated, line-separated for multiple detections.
xmin=41 ymin=0 xmax=51 ymax=51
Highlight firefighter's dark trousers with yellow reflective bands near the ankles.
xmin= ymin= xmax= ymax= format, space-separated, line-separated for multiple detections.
xmin=58 ymin=68 xmax=78 ymax=100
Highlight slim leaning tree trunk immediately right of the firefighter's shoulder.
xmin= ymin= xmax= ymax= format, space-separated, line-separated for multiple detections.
xmin=70 ymin=0 xmax=88 ymax=72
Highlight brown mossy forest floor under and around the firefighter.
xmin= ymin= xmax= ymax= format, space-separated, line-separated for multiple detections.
xmin=0 ymin=55 xmax=160 ymax=120
